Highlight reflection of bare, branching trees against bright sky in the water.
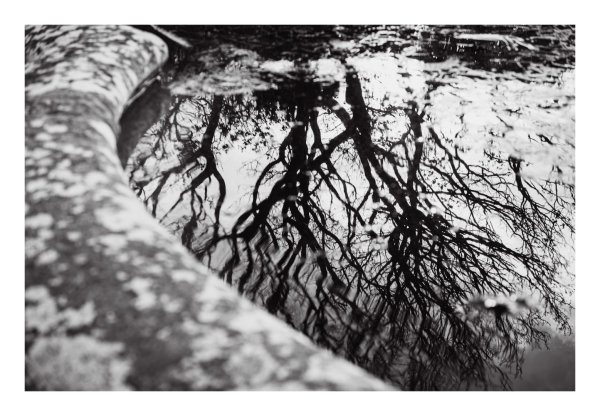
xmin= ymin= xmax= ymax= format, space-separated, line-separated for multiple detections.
xmin=126 ymin=26 xmax=575 ymax=390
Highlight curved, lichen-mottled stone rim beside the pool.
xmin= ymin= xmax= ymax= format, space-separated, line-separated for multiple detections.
xmin=25 ymin=26 xmax=388 ymax=390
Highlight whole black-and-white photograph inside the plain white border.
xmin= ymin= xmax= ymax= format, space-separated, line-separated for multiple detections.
xmin=21 ymin=19 xmax=584 ymax=404
